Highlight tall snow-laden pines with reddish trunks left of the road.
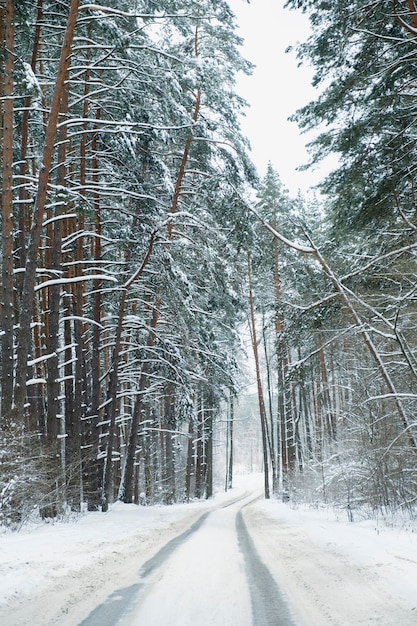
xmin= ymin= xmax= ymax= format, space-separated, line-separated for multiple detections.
xmin=0 ymin=0 xmax=256 ymax=524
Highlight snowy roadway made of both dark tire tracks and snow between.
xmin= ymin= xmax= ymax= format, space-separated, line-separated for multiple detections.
xmin=82 ymin=495 xmax=296 ymax=626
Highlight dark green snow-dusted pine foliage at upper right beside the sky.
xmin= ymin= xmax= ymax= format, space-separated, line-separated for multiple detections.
xmin=287 ymin=1 xmax=415 ymax=230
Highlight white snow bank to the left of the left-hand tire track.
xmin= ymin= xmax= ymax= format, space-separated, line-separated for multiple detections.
xmin=0 ymin=478 xmax=253 ymax=626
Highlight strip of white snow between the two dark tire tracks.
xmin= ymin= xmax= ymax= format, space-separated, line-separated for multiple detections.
xmin=118 ymin=504 xmax=252 ymax=626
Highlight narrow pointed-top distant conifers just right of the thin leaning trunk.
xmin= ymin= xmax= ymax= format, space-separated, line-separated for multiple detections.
xmin=245 ymin=164 xmax=311 ymax=499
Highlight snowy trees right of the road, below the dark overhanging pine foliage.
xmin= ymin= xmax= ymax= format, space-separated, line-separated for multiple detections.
xmin=247 ymin=160 xmax=416 ymax=519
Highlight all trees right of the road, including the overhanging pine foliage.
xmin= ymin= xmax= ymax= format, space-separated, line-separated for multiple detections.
xmin=247 ymin=2 xmax=417 ymax=510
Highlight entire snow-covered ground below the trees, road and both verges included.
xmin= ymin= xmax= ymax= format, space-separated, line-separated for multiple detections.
xmin=0 ymin=472 xmax=417 ymax=626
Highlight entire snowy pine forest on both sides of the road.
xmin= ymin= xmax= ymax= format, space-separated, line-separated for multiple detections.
xmin=0 ymin=0 xmax=417 ymax=528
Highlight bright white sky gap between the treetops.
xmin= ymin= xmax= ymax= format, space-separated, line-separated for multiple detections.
xmin=229 ymin=0 xmax=321 ymax=195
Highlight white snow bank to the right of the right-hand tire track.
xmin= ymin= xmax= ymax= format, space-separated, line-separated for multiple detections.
xmin=247 ymin=500 xmax=417 ymax=626
